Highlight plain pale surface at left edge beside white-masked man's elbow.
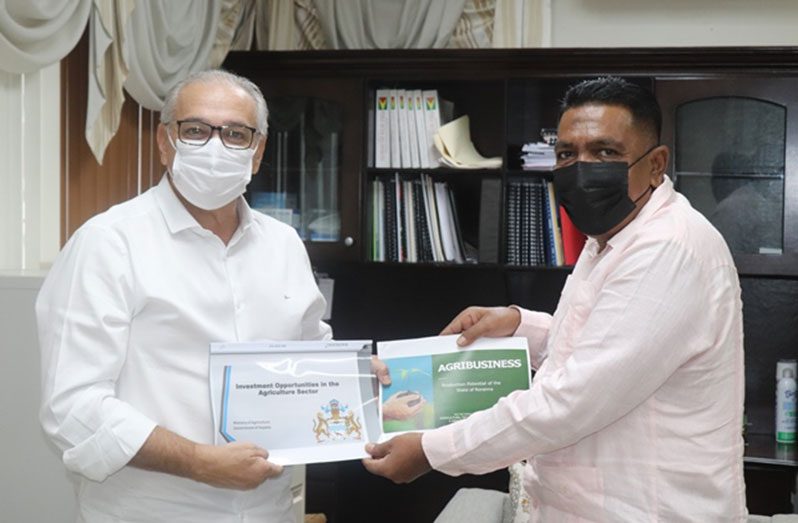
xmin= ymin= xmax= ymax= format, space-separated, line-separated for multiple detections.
xmin=0 ymin=274 xmax=75 ymax=523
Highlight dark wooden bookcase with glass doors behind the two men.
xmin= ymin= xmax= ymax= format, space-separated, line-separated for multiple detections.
xmin=224 ymin=48 xmax=798 ymax=522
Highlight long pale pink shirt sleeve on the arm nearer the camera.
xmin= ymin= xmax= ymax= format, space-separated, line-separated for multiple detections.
xmin=422 ymin=238 xmax=716 ymax=475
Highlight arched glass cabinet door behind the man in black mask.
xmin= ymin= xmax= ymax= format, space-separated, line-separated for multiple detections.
xmin=656 ymin=79 xmax=798 ymax=273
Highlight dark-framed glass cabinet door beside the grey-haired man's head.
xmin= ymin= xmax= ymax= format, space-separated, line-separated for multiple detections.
xmin=246 ymin=78 xmax=363 ymax=265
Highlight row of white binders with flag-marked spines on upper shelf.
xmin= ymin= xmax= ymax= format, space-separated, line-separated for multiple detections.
xmin=374 ymin=89 xmax=441 ymax=169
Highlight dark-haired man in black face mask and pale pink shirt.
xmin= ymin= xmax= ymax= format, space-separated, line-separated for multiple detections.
xmin=365 ymin=78 xmax=746 ymax=523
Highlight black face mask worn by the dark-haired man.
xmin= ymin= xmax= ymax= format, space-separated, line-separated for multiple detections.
xmin=554 ymin=146 xmax=656 ymax=236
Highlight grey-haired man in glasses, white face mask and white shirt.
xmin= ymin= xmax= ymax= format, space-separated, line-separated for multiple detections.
xmin=36 ymin=71 xmax=340 ymax=523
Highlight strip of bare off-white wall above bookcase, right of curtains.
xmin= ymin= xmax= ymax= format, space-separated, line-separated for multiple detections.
xmin=551 ymin=0 xmax=798 ymax=47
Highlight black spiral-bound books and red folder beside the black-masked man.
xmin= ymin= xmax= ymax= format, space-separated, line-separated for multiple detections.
xmin=505 ymin=178 xmax=585 ymax=267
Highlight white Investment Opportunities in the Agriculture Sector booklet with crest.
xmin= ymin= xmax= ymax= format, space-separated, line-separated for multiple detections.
xmin=210 ymin=340 xmax=380 ymax=465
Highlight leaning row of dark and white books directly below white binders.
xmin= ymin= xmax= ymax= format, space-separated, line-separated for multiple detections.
xmin=371 ymin=173 xmax=466 ymax=263
